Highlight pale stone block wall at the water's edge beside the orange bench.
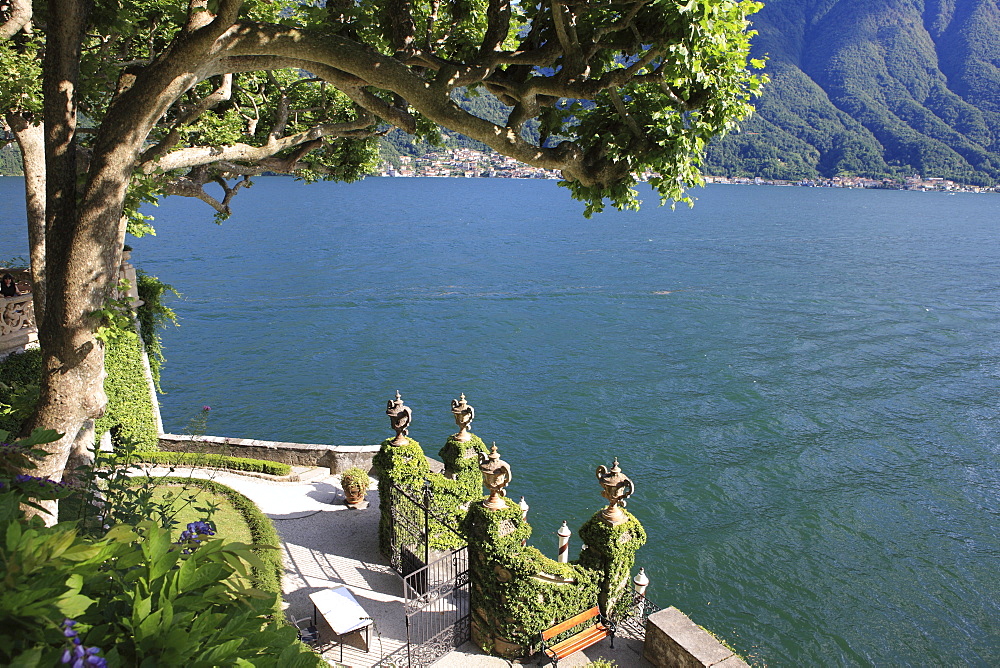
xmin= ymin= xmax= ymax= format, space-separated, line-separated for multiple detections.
xmin=642 ymin=608 xmax=749 ymax=668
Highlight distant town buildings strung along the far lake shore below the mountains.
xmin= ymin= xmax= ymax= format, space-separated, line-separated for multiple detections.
xmin=379 ymin=148 xmax=1000 ymax=193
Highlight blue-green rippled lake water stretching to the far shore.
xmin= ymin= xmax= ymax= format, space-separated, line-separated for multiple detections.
xmin=0 ymin=178 xmax=1000 ymax=666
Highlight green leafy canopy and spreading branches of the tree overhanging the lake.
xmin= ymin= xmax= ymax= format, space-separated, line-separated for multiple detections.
xmin=0 ymin=0 xmax=761 ymax=211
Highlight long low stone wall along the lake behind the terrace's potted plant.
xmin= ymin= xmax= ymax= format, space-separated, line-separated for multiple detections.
xmin=160 ymin=434 xmax=379 ymax=473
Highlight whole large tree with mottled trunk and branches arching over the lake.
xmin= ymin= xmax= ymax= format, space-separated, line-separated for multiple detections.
xmin=0 ymin=0 xmax=761 ymax=516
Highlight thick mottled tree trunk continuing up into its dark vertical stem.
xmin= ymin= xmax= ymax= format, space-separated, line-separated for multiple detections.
xmin=20 ymin=0 xmax=94 ymax=524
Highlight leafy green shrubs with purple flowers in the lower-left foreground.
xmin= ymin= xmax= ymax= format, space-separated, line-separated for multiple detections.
xmin=0 ymin=431 xmax=325 ymax=666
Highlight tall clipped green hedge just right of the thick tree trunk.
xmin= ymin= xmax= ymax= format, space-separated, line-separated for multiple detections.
xmin=95 ymin=336 xmax=160 ymax=452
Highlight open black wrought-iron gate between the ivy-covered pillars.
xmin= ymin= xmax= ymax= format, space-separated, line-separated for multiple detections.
xmin=388 ymin=485 xmax=471 ymax=668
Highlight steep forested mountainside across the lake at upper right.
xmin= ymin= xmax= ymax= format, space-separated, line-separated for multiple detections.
xmin=704 ymin=0 xmax=1000 ymax=185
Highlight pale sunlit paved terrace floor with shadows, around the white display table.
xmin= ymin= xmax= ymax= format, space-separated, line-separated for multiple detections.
xmin=150 ymin=467 xmax=652 ymax=668
